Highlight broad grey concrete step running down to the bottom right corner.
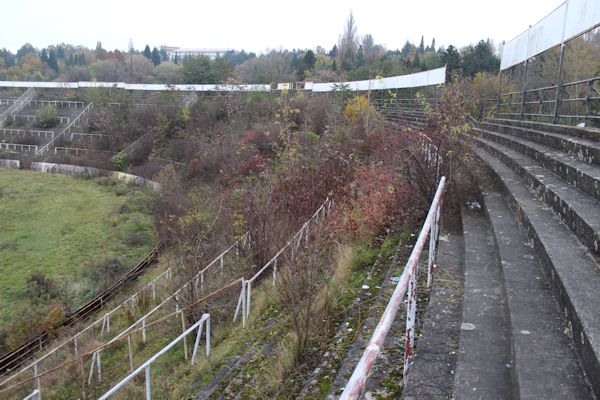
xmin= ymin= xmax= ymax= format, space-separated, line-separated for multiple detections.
xmin=480 ymin=180 xmax=592 ymax=400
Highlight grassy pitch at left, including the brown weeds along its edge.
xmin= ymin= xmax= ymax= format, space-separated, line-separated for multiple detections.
xmin=0 ymin=170 xmax=155 ymax=351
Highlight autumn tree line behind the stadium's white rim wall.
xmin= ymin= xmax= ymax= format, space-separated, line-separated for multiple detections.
xmin=0 ymin=14 xmax=500 ymax=84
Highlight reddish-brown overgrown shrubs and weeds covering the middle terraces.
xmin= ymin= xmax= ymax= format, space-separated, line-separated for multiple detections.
xmin=0 ymin=71 xmax=469 ymax=398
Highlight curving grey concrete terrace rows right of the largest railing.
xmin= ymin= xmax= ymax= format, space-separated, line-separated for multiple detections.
xmin=384 ymin=98 xmax=600 ymax=399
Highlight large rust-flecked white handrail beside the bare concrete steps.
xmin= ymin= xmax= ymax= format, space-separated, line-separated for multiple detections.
xmin=340 ymin=177 xmax=446 ymax=400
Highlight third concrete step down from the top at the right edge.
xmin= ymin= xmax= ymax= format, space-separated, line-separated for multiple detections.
xmin=474 ymin=128 xmax=600 ymax=200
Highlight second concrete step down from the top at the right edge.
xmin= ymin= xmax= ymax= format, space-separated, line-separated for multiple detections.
xmin=480 ymin=122 xmax=600 ymax=165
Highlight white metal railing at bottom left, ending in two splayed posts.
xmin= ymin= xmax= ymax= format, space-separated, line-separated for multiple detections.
xmin=99 ymin=314 xmax=210 ymax=400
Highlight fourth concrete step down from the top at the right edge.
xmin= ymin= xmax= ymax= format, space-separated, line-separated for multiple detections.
xmin=476 ymin=138 xmax=600 ymax=255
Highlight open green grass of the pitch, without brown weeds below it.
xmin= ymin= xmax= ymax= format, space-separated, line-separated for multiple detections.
xmin=0 ymin=169 xmax=155 ymax=325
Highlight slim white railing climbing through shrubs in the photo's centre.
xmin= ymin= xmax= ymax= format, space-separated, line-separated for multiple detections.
xmin=233 ymin=197 xmax=332 ymax=327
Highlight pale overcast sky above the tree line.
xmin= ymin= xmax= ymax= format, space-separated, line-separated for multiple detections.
xmin=0 ymin=0 xmax=563 ymax=52
